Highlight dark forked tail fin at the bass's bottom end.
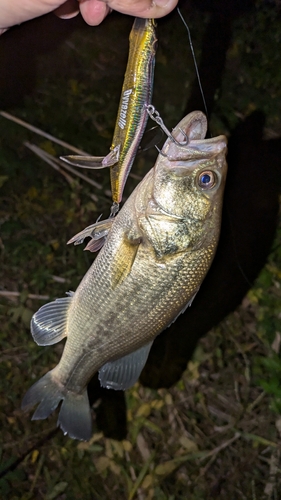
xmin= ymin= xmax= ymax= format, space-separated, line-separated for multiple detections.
xmin=22 ymin=371 xmax=92 ymax=441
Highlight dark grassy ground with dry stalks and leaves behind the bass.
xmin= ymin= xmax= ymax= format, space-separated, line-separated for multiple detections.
xmin=0 ymin=4 xmax=281 ymax=500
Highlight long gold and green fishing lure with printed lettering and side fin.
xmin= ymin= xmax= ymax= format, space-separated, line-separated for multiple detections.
xmin=61 ymin=17 xmax=157 ymax=211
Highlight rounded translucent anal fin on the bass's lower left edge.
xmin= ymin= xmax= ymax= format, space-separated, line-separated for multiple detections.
xmin=31 ymin=292 xmax=73 ymax=345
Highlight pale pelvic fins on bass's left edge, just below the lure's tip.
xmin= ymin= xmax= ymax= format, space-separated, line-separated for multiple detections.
xmin=67 ymin=217 xmax=114 ymax=252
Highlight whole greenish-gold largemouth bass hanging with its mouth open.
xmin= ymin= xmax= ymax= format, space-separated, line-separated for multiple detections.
xmin=22 ymin=111 xmax=227 ymax=441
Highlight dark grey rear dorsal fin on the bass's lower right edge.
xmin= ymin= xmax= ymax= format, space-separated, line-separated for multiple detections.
xmin=99 ymin=341 xmax=153 ymax=391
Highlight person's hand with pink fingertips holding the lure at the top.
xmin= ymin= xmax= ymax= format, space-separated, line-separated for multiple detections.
xmin=0 ymin=0 xmax=178 ymax=34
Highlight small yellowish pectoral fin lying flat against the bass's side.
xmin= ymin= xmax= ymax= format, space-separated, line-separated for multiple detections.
xmin=111 ymin=236 xmax=140 ymax=290
